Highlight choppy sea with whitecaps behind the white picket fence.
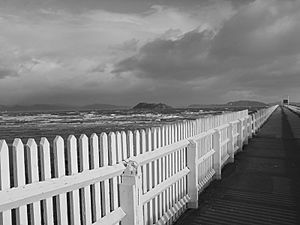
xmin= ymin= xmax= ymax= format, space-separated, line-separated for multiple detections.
xmin=0 ymin=109 xmax=219 ymax=143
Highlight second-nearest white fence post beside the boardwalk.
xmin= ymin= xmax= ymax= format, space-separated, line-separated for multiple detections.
xmin=187 ymin=140 xmax=198 ymax=209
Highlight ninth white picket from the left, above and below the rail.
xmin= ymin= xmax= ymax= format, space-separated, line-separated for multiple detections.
xmin=99 ymin=133 xmax=110 ymax=216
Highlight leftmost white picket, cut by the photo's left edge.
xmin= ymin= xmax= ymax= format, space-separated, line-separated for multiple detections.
xmin=0 ymin=140 xmax=12 ymax=225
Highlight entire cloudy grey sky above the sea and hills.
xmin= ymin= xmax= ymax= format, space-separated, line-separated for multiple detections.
xmin=0 ymin=0 xmax=300 ymax=106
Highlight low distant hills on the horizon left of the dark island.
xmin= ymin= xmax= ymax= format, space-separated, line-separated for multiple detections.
xmin=0 ymin=104 xmax=128 ymax=111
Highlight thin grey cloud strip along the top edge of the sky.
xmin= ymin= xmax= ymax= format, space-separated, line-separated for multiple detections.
xmin=0 ymin=0 xmax=253 ymax=13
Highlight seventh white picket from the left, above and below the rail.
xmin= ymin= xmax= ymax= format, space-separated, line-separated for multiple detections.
xmin=79 ymin=134 xmax=92 ymax=224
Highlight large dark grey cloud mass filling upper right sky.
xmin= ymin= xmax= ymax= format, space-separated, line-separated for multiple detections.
xmin=115 ymin=1 xmax=300 ymax=100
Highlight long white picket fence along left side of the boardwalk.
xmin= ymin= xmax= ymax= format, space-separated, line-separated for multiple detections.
xmin=0 ymin=106 xmax=277 ymax=225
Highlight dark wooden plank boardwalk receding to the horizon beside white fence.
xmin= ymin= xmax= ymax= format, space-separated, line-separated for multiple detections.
xmin=176 ymin=107 xmax=300 ymax=225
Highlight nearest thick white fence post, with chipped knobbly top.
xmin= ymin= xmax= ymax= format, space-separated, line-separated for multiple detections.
xmin=120 ymin=161 xmax=144 ymax=225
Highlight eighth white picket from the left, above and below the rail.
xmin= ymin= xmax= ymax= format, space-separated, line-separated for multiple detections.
xmin=90 ymin=133 xmax=101 ymax=222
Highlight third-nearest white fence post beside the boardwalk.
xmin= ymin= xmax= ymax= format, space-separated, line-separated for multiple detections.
xmin=213 ymin=129 xmax=222 ymax=180
